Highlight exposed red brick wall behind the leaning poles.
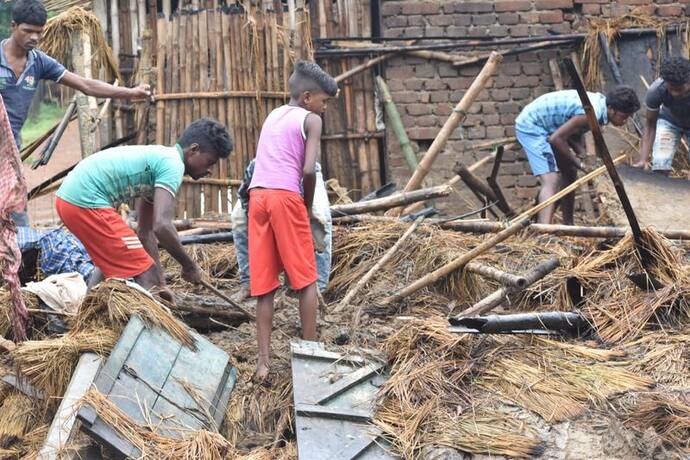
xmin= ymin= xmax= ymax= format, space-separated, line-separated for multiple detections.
xmin=382 ymin=0 xmax=690 ymax=211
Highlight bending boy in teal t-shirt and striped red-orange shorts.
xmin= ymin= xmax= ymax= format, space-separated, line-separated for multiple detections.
xmin=55 ymin=118 xmax=233 ymax=301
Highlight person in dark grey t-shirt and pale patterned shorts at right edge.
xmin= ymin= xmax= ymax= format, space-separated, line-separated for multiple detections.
xmin=633 ymin=57 xmax=690 ymax=175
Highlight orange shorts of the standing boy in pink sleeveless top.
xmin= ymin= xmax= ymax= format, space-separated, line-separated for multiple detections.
xmin=248 ymin=188 xmax=317 ymax=296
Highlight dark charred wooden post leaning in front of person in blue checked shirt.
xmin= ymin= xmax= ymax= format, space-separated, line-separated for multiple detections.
xmin=564 ymin=59 xmax=649 ymax=265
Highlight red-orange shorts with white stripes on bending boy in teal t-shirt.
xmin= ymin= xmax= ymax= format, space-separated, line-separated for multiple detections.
xmin=55 ymin=198 xmax=154 ymax=278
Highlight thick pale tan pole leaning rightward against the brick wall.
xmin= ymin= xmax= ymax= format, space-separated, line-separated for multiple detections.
xmin=398 ymin=52 xmax=501 ymax=192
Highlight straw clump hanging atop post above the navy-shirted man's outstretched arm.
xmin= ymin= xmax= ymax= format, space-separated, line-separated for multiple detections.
xmin=40 ymin=6 xmax=121 ymax=79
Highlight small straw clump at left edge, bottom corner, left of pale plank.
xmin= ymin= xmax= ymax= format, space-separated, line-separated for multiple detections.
xmin=0 ymin=390 xmax=40 ymax=449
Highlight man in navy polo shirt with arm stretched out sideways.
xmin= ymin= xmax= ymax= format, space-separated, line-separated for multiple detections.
xmin=0 ymin=0 xmax=151 ymax=226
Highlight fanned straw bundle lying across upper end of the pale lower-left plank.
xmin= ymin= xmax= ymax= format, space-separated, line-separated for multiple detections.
xmin=12 ymin=329 xmax=119 ymax=404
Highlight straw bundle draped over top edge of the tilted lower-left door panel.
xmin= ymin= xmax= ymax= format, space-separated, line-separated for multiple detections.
xmin=74 ymin=279 xmax=194 ymax=347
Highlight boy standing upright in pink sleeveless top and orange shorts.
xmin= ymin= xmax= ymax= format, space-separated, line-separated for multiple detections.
xmin=249 ymin=61 xmax=338 ymax=380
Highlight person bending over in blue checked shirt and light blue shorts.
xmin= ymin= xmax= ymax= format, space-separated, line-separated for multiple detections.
xmin=515 ymin=85 xmax=640 ymax=225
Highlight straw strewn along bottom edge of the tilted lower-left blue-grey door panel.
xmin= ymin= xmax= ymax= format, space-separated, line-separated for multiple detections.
xmin=81 ymin=389 xmax=230 ymax=460
